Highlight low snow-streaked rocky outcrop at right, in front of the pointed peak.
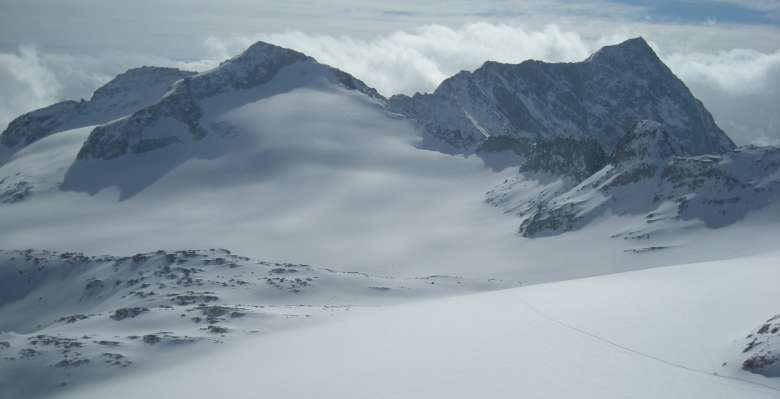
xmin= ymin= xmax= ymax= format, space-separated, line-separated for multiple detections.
xmin=488 ymin=121 xmax=780 ymax=239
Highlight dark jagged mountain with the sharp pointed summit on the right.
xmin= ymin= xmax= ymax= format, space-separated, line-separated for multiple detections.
xmin=389 ymin=38 xmax=734 ymax=154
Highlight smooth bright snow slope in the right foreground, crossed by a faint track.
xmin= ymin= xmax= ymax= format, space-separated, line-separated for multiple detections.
xmin=47 ymin=253 xmax=780 ymax=399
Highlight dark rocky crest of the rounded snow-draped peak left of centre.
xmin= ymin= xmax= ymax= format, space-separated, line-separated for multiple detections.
xmin=78 ymin=42 xmax=383 ymax=160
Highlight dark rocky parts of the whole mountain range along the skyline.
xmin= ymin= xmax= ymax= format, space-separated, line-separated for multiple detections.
xmin=0 ymin=38 xmax=780 ymax=238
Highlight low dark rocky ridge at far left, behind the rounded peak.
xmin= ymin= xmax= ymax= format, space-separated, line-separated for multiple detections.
xmin=0 ymin=66 xmax=195 ymax=151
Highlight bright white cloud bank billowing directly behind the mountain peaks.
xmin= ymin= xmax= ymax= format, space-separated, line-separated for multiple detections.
xmin=0 ymin=22 xmax=780 ymax=144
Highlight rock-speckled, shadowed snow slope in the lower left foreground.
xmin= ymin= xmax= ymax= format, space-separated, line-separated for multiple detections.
xmin=0 ymin=249 xmax=511 ymax=398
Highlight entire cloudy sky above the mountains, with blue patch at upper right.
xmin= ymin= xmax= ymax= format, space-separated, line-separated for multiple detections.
xmin=0 ymin=0 xmax=780 ymax=144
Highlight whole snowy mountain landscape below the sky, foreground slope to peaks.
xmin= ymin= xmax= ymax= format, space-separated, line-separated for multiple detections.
xmin=0 ymin=38 xmax=780 ymax=398
